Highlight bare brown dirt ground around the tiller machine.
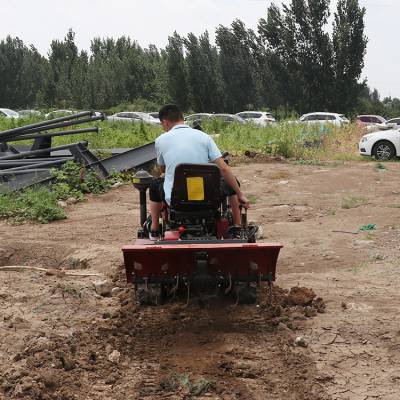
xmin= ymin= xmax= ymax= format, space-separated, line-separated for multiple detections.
xmin=0 ymin=163 xmax=400 ymax=400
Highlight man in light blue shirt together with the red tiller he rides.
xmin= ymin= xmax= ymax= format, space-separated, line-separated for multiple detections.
xmin=123 ymin=105 xmax=282 ymax=303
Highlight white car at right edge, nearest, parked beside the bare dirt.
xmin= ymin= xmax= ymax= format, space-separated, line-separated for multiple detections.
xmin=358 ymin=129 xmax=400 ymax=161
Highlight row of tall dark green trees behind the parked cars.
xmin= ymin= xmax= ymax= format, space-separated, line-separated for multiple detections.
xmin=0 ymin=0 xmax=400 ymax=118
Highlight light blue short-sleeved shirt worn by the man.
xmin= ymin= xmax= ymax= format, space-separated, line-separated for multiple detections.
xmin=156 ymin=124 xmax=221 ymax=204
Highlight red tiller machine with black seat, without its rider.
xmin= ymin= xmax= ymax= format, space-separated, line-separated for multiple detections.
xmin=122 ymin=164 xmax=283 ymax=304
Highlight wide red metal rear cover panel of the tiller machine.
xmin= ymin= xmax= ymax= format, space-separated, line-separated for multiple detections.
xmin=122 ymin=239 xmax=283 ymax=282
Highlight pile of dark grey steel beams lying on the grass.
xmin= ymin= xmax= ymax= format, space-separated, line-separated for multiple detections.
xmin=0 ymin=111 xmax=157 ymax=194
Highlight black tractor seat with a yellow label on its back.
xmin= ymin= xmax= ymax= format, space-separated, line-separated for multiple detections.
xmin=170 ymin=164 xmax=221 ymax=220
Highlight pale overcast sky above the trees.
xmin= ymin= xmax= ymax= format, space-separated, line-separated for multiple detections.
xmin=0 ymin=0 xmax=400 ymax=97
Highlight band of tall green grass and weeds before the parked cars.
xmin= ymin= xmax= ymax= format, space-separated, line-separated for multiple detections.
xmin=0 ymin=118 xmax=363 ymax=160
